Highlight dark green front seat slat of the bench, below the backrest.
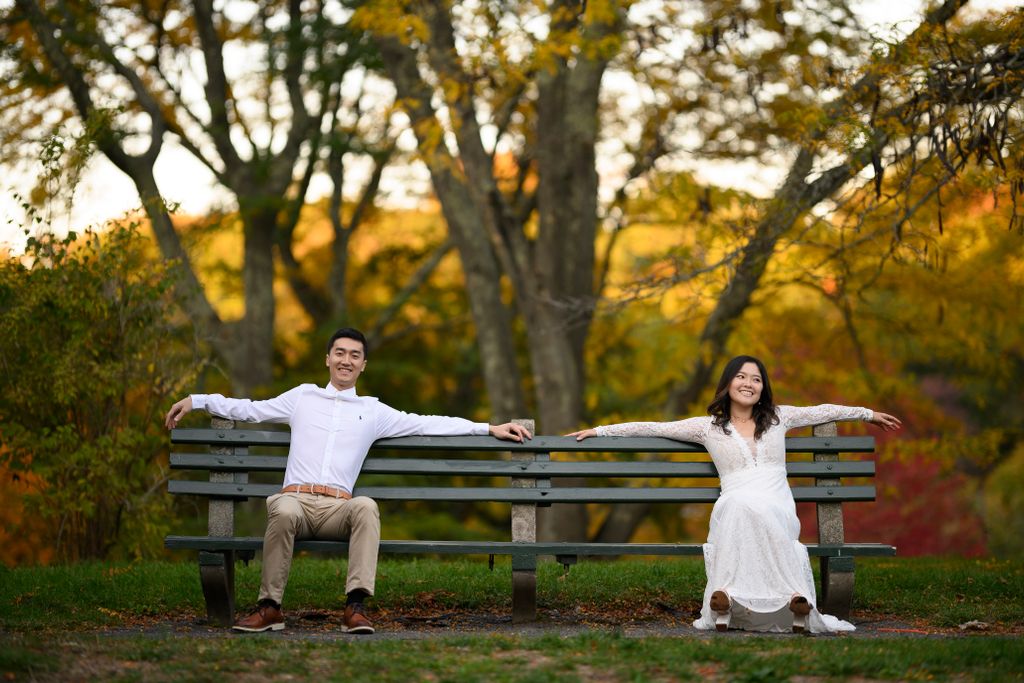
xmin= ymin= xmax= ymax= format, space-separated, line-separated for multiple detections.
xmin=164 ymin=536 xmax=896 ymax=557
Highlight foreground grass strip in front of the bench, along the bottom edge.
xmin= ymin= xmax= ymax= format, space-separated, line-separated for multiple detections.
xmin=0 ymin=632 xmax=1024 ymax=683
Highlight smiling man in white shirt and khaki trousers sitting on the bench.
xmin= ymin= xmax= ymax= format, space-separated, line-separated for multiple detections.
xmin=166 ymin=328 xmax=530 ymax=633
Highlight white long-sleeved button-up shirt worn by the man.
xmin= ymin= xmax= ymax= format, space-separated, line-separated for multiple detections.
xmin=191 ymin=384 xmax=489 ymax=493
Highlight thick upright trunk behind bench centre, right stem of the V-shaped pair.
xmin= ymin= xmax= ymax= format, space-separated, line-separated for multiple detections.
xmin=520 ymin=6 xmax=617 ymax=541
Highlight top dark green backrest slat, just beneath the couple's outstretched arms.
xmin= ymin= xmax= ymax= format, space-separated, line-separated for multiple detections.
xmin=171 ymin=428 xmax=874 ymax=453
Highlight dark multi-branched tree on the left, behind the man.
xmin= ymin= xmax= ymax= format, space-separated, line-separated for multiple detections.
xmin=0 ymin=0 xmax=403 ymax=393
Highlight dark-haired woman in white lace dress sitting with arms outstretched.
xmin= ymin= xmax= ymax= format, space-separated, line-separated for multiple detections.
xmin=570 ymin=355 xmax=900 ymax=633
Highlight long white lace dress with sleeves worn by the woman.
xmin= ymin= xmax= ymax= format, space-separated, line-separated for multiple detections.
xmin=596 ymin=404 xmax=872 ymax=633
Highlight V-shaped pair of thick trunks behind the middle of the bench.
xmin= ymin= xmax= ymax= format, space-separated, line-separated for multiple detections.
xmin=377 ymin=1 xmax=621 ymax=540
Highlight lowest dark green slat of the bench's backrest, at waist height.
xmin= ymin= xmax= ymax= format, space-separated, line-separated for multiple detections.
xmin=167 ymin=479 xmax=874 ymax=503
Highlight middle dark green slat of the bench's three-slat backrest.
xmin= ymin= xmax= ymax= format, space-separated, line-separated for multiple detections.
xmin=171 ymin=453 xmax=874 ymax=477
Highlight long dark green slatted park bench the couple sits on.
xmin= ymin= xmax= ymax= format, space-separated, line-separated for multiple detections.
xmin=165 ymin=418 xmax=896 ymax=626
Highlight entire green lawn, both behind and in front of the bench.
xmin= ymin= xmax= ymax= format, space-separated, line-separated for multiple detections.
xmin=0 ymin=558 xmax=1024 ymax=682
